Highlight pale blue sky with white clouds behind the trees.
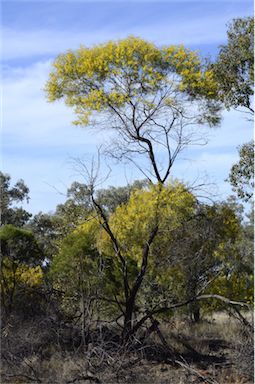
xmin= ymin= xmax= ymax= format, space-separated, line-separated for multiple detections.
xmin=1 ymin=0 xmax=253 ymax=213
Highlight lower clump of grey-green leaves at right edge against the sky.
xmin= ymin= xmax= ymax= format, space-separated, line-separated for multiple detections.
xmin=228 ymin=140 xmax=254 ymax=202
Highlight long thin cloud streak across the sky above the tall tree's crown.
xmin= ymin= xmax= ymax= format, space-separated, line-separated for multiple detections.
xmin=3 ymin=8 xmax=251 ymax=60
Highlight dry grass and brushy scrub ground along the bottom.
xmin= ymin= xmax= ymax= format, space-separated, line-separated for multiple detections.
xmin=1 ymin=313 xmax=253 ymax=384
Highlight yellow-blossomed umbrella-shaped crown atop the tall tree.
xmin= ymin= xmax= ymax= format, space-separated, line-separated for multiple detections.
xmin=46 ymin=36 xmax=216 ymax=124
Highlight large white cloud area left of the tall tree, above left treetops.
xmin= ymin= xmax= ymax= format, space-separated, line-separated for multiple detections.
xmin=1 ymin=61 xmax=110 ymax=213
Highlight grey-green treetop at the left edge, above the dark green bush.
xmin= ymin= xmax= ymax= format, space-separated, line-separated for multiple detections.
xmin=0 ymin=172 xmax=32 ymax=227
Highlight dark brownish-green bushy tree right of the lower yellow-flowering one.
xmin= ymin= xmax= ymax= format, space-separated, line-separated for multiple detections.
xmin=166 ymin=203 xmax=241 ymax=321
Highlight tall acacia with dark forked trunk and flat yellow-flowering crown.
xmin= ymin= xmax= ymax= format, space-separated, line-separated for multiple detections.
xmin=46 ymin=37 xmax=220 ymax=340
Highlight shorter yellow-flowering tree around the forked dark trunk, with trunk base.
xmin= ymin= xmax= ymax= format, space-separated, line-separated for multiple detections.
xmin=92 ymin=183 xmax=194 ymax=339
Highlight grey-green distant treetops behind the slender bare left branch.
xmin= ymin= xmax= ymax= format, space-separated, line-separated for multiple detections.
xmin=27 ymin=181 xmax=149 ymax=269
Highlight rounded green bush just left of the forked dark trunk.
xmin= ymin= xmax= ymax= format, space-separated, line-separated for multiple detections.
xmin=49 ymin=218 xmax=101 ymax=314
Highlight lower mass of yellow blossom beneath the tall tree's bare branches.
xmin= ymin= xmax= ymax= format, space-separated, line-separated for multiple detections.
xmin=98 ymin=184 xmax=194 ymax=266
